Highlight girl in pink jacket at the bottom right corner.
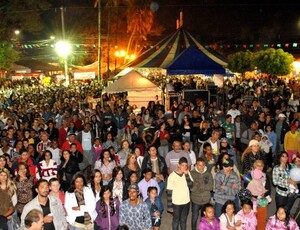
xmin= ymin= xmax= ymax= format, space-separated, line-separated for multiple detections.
xmin=266 ymin=206 xmax=299 ymax=230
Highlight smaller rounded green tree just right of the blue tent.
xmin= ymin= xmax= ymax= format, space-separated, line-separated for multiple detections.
xmin=228 ymin=50 xmax=254 ymax=75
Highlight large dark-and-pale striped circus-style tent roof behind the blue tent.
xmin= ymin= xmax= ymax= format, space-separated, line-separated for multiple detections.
xmin=123 ymin=28 xmax=227 ymax=69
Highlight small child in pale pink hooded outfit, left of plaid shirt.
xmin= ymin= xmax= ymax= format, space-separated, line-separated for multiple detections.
xmin=247 ymin=169 xmax=272 ymax=212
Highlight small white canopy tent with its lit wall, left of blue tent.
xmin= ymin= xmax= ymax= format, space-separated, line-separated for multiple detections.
xmin=102 ymin=70 xmax=162 ymax=108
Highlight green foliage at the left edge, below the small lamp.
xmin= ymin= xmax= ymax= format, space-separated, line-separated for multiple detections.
xmin=0 ymin=42 xmax=19 ymax=70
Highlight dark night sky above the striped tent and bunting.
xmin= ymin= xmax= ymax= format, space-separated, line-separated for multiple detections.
xmin=20 ymin=0 xmax=300 ymax=59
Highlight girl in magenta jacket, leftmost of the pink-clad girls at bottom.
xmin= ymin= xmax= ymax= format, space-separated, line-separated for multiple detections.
xmin=198 ymin=204 xmax=220 ymax=230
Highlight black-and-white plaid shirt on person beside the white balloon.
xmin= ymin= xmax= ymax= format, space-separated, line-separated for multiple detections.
xmin=272 ymin=165 xmax=290 ymax=196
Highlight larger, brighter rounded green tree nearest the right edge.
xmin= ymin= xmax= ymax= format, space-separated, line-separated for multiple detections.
xmin=254 ymin=48 xmax=294 ymax=76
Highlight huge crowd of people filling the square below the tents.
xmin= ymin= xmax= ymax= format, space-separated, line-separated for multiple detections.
xmin=0 ymin=76 xmax=300 ymax=230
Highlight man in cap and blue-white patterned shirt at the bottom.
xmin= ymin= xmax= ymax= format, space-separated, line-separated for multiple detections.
xmin=120 ymin=184 xmax=152 ymax=230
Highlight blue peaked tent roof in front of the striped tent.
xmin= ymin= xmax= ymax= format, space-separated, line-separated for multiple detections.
xmin=167 ymin=45 xmax=226 ymax=75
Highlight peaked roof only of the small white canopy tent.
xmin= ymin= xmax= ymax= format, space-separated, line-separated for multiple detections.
xmin=104 ymin=70 xmax=158 ymax=93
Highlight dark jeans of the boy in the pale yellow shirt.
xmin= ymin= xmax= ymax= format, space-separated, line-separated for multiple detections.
xmin=172 ymin=203 xmax=190 ymax=230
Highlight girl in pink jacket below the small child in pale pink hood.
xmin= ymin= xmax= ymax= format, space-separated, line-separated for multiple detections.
xmin=237 ymin=199 xmax=257 ymax=230
